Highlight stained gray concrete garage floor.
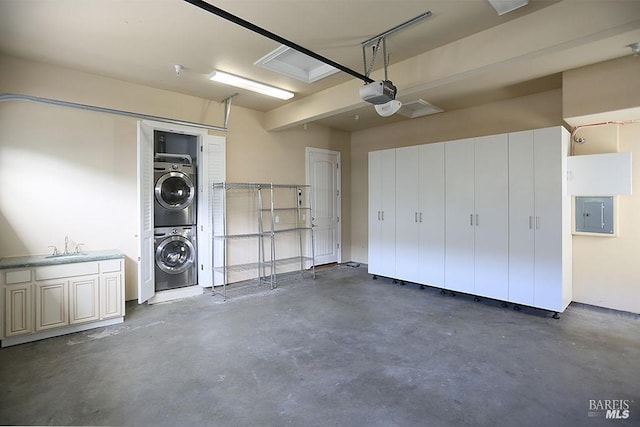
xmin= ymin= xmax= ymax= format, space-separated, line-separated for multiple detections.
xmin=0 ymin=266 xmax=640 ymax=427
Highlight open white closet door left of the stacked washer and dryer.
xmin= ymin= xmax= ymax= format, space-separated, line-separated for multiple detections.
xmin=138 ymin=121 xmax=155 ymax=304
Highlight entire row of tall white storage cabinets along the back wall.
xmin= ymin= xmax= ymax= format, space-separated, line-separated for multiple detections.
xmin=369 ymin=127 xmax=572 ymax=312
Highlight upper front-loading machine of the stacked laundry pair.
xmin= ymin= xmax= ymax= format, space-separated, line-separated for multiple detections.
xmin=153 ymin=156 xmax=197 ymax=227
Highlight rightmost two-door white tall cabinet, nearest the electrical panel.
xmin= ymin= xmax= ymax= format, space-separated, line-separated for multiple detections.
xmin=509 ymin=127 xmax=572 ymax=312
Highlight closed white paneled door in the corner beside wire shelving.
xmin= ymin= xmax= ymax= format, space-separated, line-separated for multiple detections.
xmin=306 ymin=147 xmax=341 ymax=265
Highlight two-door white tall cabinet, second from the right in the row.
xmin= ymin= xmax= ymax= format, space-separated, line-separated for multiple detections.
xmin=445 ymin=134 xmax=509 ymax=299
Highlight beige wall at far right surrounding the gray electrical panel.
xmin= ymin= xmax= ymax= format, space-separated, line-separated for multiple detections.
xmin=562 ymin=56 xmax=640 ymax=313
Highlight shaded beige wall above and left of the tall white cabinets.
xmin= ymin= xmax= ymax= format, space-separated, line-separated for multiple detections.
xmin=351 ymin=89 xmax=563 ymax=263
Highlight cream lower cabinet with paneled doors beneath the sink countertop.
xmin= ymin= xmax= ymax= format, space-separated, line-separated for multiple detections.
xmin=0 ymin=254 xmax=124 ymax=347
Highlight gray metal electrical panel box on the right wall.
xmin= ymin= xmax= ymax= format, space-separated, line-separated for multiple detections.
xmin=575 ymin=196 xmax=614 ymax=234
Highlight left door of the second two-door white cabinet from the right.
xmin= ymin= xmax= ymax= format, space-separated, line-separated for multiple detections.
xmin=445 ymin=139 xmax=475 ymax=293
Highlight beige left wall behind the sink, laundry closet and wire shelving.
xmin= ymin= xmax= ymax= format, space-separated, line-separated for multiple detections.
xmin=0 ymin=56 xmax=350 ymax=299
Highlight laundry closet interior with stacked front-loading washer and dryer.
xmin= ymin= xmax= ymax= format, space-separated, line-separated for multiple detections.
xmin=153 ymin=131 xmax=198 ymax=291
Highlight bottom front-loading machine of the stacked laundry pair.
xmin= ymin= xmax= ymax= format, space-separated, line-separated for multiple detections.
xmin=154 ymin=226 xmax=198 ymax=291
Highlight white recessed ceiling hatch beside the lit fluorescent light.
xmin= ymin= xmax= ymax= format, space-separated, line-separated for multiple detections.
xmin=254 ymin=45 xmax=339 ymax=83
